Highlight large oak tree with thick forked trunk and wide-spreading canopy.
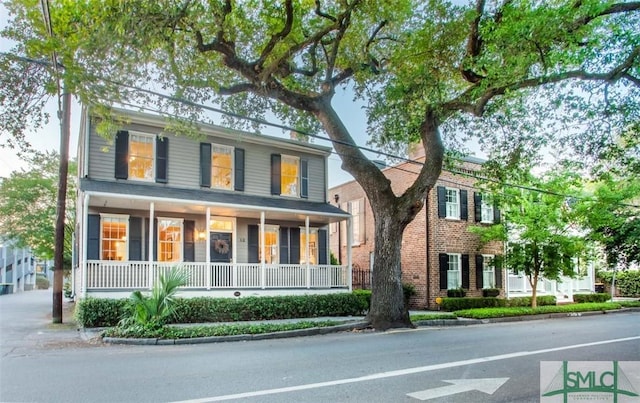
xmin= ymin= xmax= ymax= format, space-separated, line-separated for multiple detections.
xmin=2 ymin=0 xmax=640 ymax=329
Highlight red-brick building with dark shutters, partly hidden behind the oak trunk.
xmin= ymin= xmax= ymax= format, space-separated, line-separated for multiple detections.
xmin=329 ymin=147 xmax=505 ymax=309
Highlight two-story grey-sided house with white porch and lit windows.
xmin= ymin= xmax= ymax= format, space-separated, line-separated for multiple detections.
xmin=74 ymin=108 xmax=351 ymax=298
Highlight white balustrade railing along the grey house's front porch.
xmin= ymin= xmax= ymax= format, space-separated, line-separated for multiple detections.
xmin=87 ymin=260 xmax=349 ymax=289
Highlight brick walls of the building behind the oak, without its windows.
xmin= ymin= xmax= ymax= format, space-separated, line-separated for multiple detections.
xmin=329 ymin=158 xmax=505 ymax=309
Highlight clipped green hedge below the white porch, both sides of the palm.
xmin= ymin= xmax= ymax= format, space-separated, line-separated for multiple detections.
xmin=76 ymin=291 xmax=371 ymax=327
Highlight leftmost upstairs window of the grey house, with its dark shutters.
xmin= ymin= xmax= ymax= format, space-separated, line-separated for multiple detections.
xmin=115 ymin=131 xmax=169 ymax=183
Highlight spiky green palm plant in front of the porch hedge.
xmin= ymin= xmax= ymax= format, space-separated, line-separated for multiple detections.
xmin=121 ymin=268 xmax=188 ymax=327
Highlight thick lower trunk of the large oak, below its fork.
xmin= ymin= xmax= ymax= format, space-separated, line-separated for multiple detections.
xmin=367 ymin=212 xmax=413 ymax=330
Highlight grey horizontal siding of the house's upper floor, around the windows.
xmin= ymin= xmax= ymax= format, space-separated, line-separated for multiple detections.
xmin=88 ymin=119 xmax=327 ymax=202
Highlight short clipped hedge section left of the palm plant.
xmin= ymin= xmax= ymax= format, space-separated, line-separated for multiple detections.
xmin=76 ymin=298 xmax=129 ymax=327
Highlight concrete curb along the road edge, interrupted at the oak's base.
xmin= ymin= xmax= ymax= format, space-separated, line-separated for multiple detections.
xmin=92 ymin=308 xmax=640 ymax=346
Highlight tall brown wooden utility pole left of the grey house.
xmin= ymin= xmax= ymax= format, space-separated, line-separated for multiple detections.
xmin=51 ymin=85 xmax=71 ymax=323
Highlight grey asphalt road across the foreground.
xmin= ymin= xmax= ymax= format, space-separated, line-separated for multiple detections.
xmin=0 ymin=297 xmax=640 ymax=403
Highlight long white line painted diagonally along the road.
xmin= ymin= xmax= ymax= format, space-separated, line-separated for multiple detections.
xmin=173 ymin=336 xmax=640 ymax=403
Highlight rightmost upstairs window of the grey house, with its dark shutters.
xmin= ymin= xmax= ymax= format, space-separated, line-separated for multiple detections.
xmin=271 ymin=154 xmax=309 ymax=198
